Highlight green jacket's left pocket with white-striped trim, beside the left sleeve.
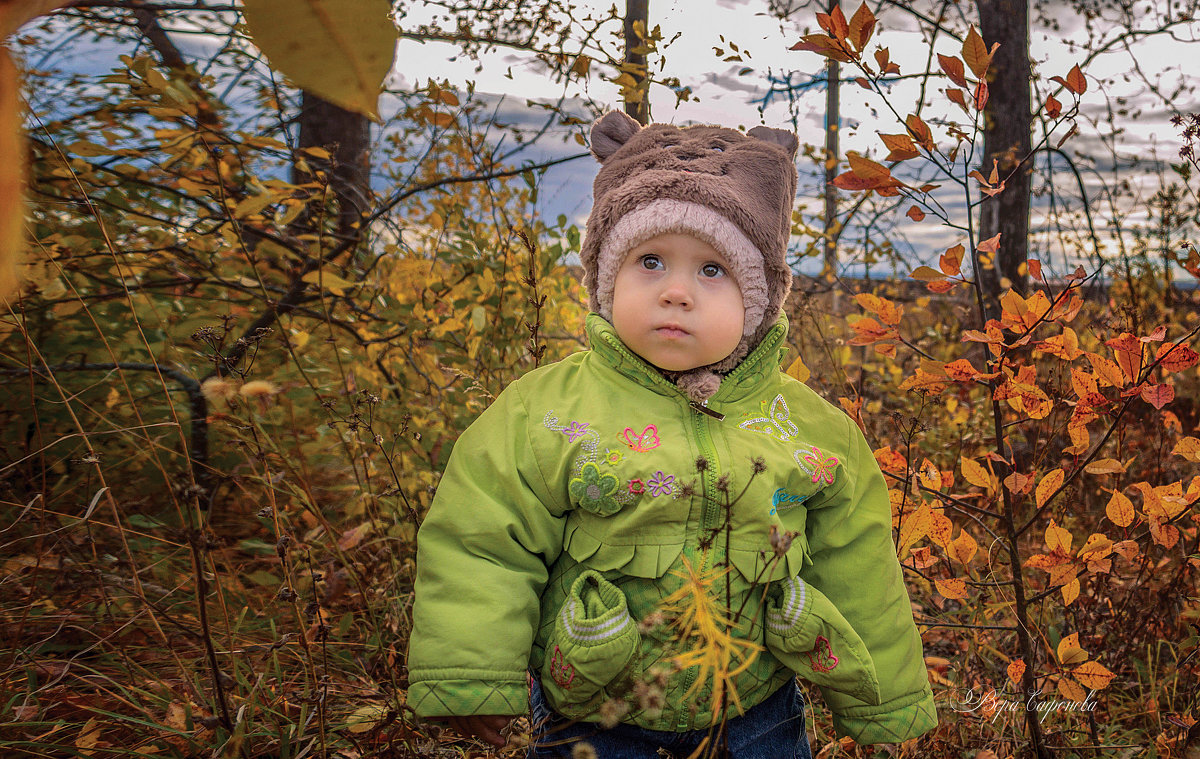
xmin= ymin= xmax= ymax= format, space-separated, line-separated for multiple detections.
xmin=541 ymin=569 xmax=641 ymax=713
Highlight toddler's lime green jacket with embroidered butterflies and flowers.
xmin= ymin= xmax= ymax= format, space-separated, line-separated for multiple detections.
xmin=408 ymin=315 xmax=937 ymax=743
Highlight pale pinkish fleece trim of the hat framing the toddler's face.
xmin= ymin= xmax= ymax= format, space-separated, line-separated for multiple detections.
xmin=596 ymin=201 xmax=767 ymax=337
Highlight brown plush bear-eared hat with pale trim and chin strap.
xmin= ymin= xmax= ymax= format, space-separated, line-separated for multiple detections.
xmin=580 ymin=110 xmax=798 ymax=400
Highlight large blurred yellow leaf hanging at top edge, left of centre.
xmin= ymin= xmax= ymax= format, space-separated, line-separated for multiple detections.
xmin=242 ymin=0 xmax=396 ymax=119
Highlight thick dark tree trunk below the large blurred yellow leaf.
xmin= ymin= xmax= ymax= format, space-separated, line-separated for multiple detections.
xmin=292 ymin=92 xmax=371 ymax=239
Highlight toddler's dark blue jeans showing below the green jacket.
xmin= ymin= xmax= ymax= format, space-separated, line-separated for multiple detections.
xmin=528 ymin=677 xmax=812 ymax=759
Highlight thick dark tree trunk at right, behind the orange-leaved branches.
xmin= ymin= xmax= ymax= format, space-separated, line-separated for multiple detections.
xmin=978 ymin=0 xmax=1033 ymax=317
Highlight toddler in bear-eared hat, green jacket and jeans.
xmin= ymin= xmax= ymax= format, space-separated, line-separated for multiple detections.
xmin=408 ymin=112 xmax=937 ymax=759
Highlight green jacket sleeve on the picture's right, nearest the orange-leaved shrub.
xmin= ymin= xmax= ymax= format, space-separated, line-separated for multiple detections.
xmin=800 ymin=417 xmax=937 ymax=743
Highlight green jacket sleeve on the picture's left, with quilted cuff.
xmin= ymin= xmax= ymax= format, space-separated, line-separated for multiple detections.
xmin=408 ymin=383 xmax=565 ymax=717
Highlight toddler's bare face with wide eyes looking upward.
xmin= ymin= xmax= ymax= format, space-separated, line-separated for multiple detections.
xmin=612 ymin=233 xmax=745 ymax=371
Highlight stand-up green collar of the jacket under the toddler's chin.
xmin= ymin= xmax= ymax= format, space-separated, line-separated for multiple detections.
xmin=586 ymin=312 xmax=787 ymax=402
